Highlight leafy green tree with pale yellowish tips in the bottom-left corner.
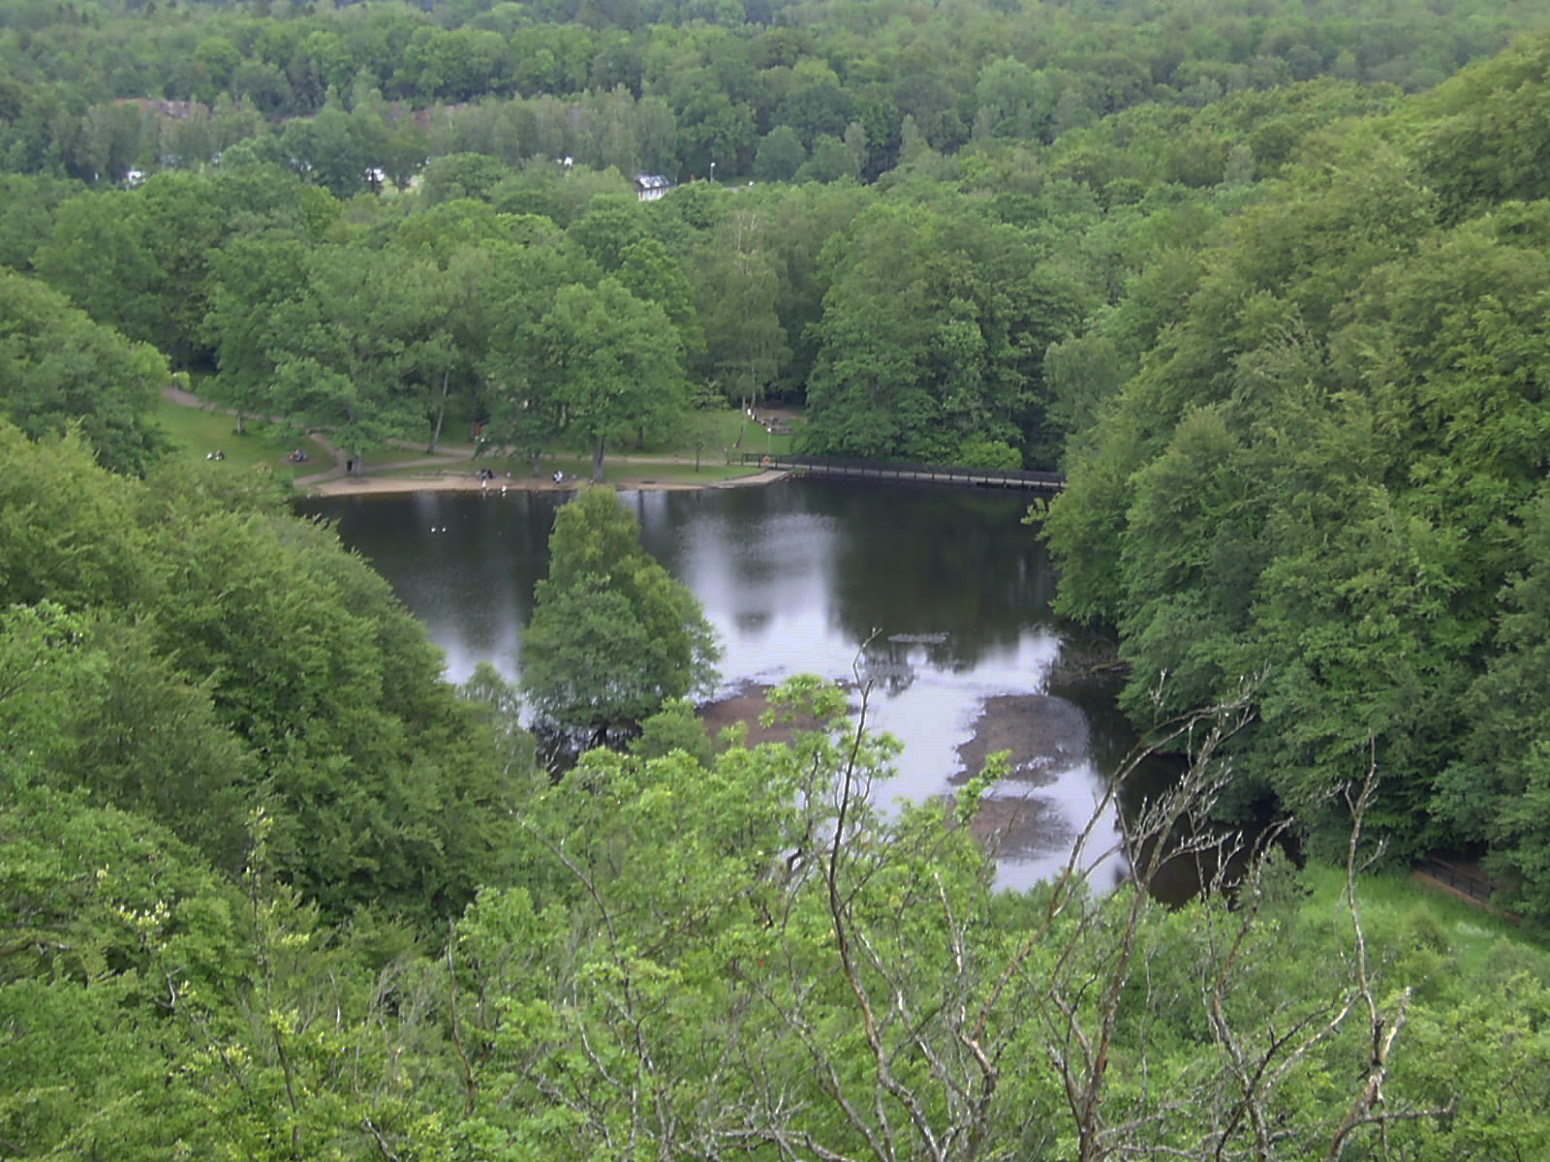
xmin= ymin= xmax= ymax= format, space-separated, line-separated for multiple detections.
xmin=0 ymin=787 xmax=251 ymax=1162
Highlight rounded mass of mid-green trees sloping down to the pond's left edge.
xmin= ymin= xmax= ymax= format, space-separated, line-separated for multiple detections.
xmin=0 ymin=428 xmax=522 ymax=925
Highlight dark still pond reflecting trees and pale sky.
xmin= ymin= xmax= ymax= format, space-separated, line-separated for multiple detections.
xmin=301 ymin=480 xmax=1159 ymax=888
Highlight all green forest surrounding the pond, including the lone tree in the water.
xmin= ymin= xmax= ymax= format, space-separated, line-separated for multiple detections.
xmin=12 ymin=0 xmax=1550 ymax=1162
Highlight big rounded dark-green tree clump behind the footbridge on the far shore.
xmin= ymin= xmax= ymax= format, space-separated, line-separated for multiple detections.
xmin=803 ymin=198 xmax=1091 ymax=465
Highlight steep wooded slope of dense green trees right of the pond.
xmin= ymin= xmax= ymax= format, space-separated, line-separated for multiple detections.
xmin=1046 ymin=31 xmax=1550 ymax=917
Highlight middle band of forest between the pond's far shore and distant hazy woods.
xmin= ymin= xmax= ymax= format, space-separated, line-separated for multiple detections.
xmin=0 ymin=73 xmax=1397 ymax=468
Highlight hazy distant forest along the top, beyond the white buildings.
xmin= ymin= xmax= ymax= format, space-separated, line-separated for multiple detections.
xmin=0 ymin=0 xmax=1547 ymax=187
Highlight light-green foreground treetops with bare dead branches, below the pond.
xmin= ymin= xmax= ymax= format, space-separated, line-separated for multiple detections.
xmin=456 ymin=679 xmax=1488 ymax=1162
